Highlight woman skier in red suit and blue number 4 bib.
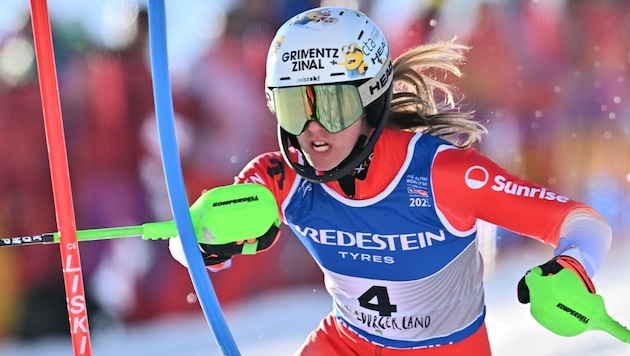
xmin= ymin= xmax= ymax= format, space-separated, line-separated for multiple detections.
xmin=171 ymin=7 xmax=611 ymax=356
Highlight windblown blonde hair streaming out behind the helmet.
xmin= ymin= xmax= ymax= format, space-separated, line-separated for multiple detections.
xmin=387 ymin=41 xmax=487 ymax=148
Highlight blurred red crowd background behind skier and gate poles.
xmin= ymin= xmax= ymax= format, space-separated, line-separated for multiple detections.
xmin=0 ymin=0 xmax=630 ymax=339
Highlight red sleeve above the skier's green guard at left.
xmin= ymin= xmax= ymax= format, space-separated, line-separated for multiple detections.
xmin=234 ymin=152 xmax=296 ymax=220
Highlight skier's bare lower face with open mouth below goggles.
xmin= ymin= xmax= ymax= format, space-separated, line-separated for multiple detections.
xmin=297 ymin=117 xmax=372 ymax=171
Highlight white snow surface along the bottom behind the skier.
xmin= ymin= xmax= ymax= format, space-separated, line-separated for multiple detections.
xmin=0 ymin=246 xmax=630 ymax=356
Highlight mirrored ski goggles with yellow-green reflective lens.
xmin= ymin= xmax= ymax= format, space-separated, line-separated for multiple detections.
xmin=271 ymin=84 xmax=363 ymax=136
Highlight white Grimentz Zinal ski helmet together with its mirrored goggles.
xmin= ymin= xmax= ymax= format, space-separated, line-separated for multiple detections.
xmin=265 ymin=7 xmax=393 ymax=183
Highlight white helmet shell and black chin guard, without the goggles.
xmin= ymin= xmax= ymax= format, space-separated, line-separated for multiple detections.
xmin=265 ymin=7 xmax=393 ymax=182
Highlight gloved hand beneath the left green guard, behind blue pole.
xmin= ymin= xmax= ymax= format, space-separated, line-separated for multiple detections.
xmin=169 ymin=226 xmax=280 ymax=271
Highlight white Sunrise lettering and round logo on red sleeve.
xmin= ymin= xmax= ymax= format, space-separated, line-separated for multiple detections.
xmin=464 ymin=166 xmax=569 ymax=203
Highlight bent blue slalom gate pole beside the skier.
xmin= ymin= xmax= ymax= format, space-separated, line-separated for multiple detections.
xmin=148 ymin=0 xmax=240 ymax=356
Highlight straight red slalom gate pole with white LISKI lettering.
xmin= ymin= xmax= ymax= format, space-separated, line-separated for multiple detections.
xmin=31 ymin=0 xmax=92 ymax=355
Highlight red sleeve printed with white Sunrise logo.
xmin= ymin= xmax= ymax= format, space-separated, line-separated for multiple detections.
xmin=431 ymin=149 xmax=591 ymax=246
